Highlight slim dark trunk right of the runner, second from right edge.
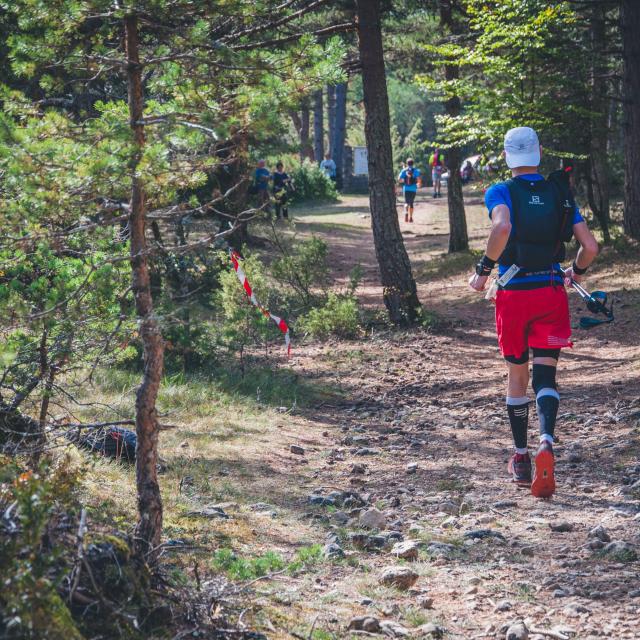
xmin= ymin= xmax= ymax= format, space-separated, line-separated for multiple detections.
xmin=587 ymin=5 xmax=611 ymax=244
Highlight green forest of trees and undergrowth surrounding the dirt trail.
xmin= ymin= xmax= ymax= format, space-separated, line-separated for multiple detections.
xmin=0 ymin=0 xmax=640 ymax=638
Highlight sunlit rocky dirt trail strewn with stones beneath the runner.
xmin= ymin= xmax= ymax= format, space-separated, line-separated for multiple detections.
xmin=160 ymin=191 xmax=640 ymax=640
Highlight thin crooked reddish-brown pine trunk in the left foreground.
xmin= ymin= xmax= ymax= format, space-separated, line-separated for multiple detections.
xmin=124 ymin=15 xmax=164 ymax=562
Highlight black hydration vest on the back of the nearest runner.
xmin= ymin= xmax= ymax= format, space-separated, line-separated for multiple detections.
xmin=498 ymin=173 xmax=575 ymax=271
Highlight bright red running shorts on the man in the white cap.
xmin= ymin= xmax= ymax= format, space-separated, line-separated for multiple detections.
xmin=496 ymin=286 xmax=573 ymax=358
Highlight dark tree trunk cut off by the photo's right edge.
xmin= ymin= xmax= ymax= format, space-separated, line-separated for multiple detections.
xmin=620 ymin=0 xmax=640 ymax=240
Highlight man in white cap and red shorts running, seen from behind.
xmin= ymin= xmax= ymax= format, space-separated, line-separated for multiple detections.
xmin=469 ymin=127 xmax=598 ymax=498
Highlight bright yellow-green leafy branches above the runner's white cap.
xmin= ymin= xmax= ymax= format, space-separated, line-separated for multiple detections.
xmin=416 ymin=0 xmax=589 ymax=160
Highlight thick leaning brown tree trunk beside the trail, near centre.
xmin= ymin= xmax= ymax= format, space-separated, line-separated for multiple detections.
xmin=356 ymin=0 xmax=420 ymax=325
